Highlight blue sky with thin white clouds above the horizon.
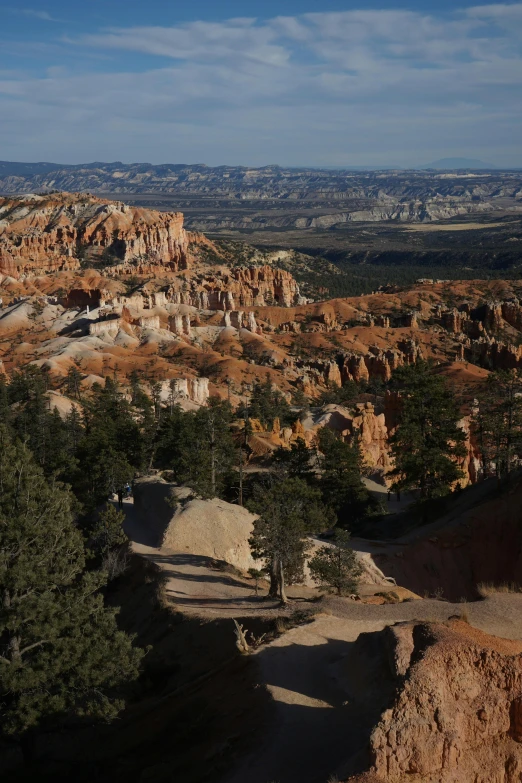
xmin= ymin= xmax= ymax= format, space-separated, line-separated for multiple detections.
xmin=0 ymin=0 xmax=522 ymax=167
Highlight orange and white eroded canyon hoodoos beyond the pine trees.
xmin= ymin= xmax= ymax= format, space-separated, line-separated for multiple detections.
xmin=0 ymin=194 xmax=522 ymax=490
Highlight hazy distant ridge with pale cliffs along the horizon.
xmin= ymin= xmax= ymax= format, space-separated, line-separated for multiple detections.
xmin=0 ymin=162 xmax=522 ymax=230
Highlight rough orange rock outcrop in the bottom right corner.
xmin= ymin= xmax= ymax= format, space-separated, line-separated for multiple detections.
xmin=348 ymin=620 xmax=522 ymax=783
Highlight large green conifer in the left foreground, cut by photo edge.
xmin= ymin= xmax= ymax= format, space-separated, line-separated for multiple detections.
xmin=0 ymin=427 xmax=142 ymax=738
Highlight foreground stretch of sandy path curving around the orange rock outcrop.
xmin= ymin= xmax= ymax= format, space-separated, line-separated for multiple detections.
xmin=224 ymin=594 xmax=522 ymax=783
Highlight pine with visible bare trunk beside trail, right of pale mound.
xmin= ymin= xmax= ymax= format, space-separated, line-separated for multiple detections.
xmin=248 ymin=478 xmax=331 ymax=603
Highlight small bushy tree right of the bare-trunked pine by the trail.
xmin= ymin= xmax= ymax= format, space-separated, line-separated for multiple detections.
xmin=308 ymin=530 xmax=362 ymax=595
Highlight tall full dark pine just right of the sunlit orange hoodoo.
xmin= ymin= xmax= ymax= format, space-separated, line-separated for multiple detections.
xmin=390 ymin=362 xmax=466 ymax=498
